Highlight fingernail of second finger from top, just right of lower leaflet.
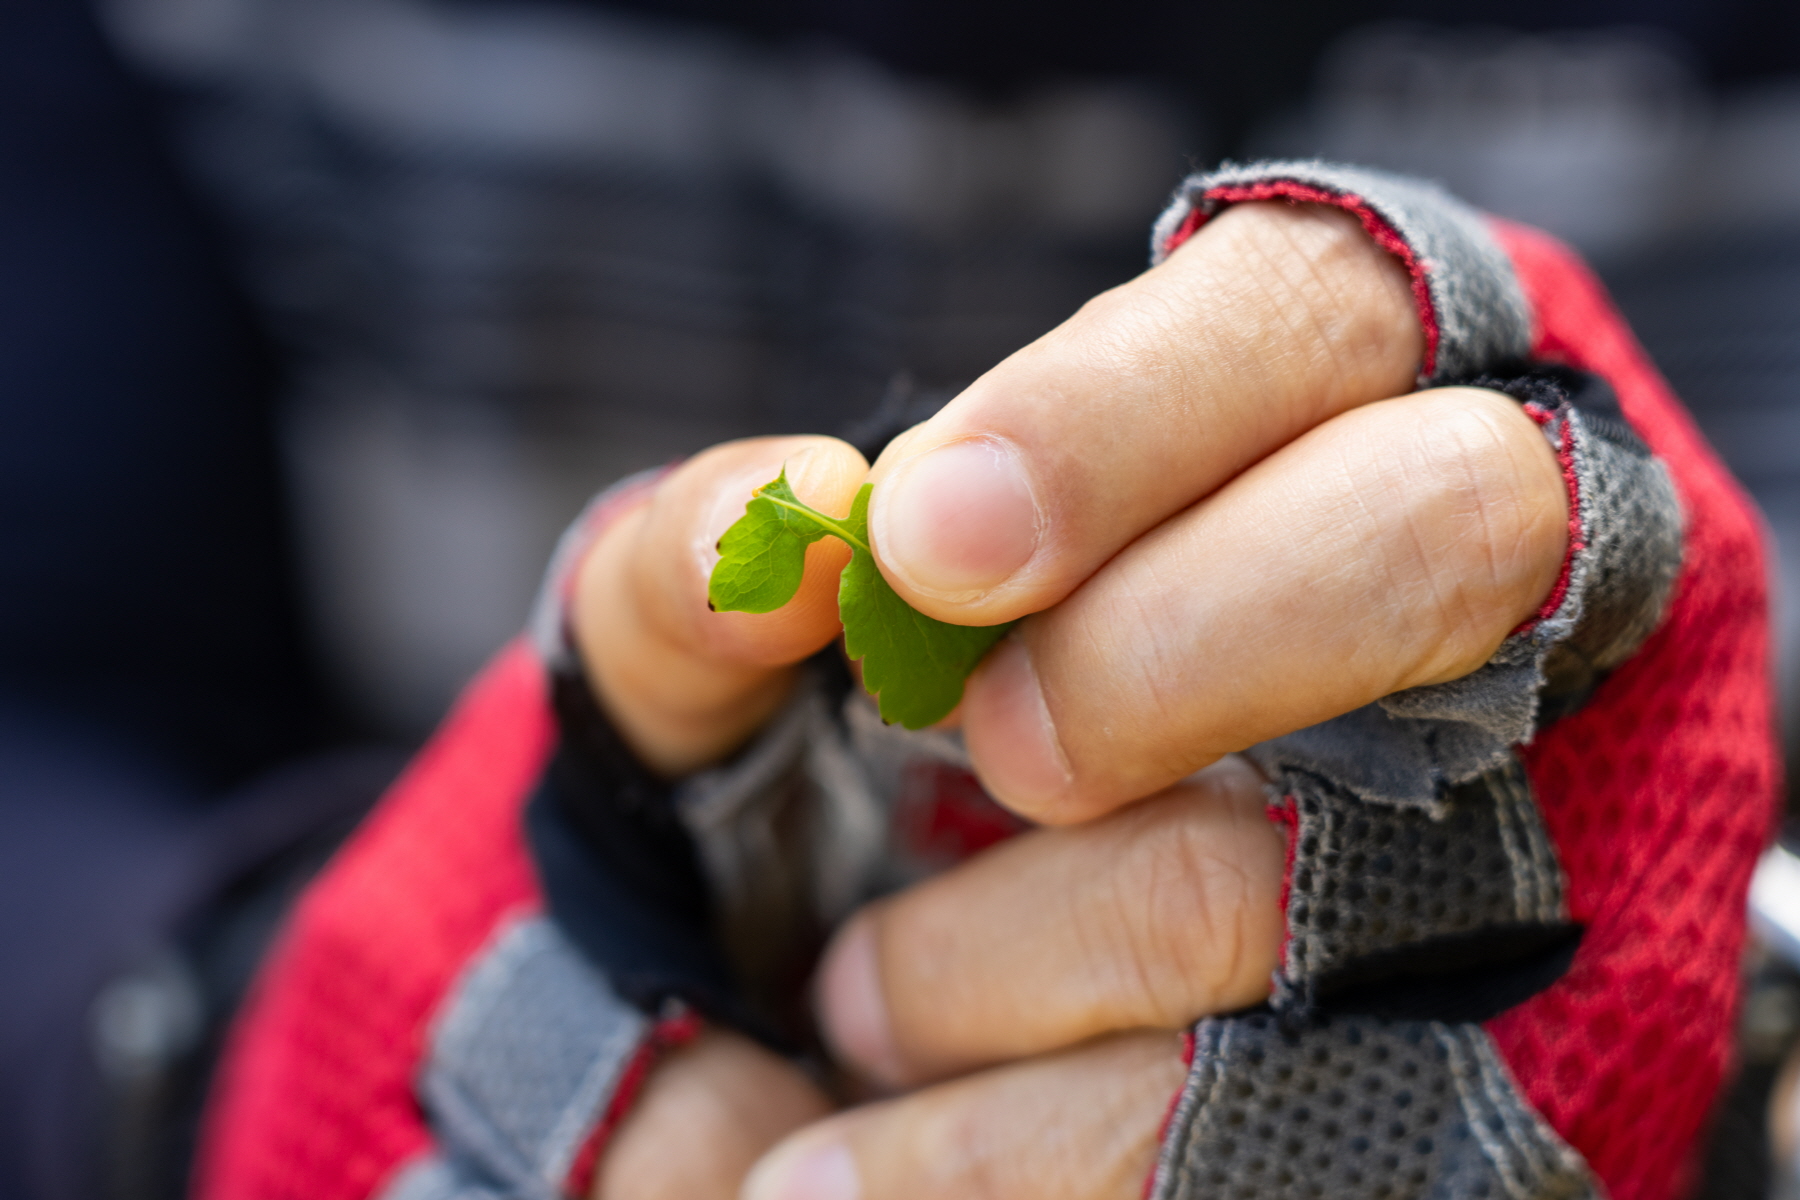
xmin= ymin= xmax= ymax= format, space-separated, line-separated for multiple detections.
xmin=963 ymin=635 xmax=1075 ymax=819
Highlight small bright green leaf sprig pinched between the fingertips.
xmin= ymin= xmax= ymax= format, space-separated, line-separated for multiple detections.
xmin=707 ymin=470 xmax=1012 ymax=729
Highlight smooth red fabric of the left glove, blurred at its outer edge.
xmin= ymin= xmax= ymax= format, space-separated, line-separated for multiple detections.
xmin=196 ymin=646 xmax=553 ymax=1200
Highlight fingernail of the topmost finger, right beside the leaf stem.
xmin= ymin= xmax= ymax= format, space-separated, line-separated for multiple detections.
xmin=869 ymin=437 xmax=1042 ymax=601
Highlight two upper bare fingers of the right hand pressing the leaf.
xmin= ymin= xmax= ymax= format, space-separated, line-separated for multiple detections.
xmin=869 ymin=203 xmax=1568 ymax=822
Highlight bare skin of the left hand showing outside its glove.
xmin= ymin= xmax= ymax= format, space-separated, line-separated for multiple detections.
xmin=571 ymin=437 xmax=868 ymax=1200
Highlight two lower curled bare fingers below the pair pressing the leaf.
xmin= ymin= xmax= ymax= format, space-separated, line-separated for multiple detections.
xmin=743 ymin=757 xmax=1283 ymax=1200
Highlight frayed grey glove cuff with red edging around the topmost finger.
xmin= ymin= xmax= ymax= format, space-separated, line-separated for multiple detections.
xmin=1150 ymin=160 xmax=1532 ymax=385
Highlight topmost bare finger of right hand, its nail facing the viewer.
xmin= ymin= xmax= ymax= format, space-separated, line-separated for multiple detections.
xmin=869 ymin=203 xmax=1424 ymax=624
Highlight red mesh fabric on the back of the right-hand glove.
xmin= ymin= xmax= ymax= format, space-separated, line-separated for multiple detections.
xmin=1487 ymin=223 xmax=1778 ymax=1200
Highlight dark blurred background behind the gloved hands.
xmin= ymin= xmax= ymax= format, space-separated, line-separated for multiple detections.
xmin=0 ymin=0 xmax=1800 ymax=1198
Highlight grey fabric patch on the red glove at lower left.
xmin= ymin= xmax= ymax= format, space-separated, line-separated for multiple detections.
xmin=419 ymin=916 xmax=650 ymax=1200
